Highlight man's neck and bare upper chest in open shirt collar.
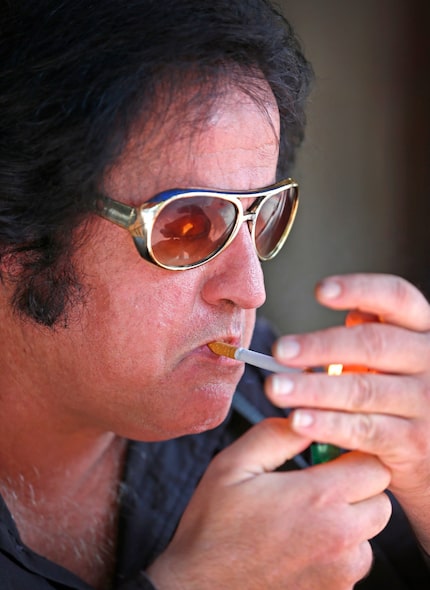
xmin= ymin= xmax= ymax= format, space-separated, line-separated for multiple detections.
xmin=0 ymin=308 xmax=125 ymax=588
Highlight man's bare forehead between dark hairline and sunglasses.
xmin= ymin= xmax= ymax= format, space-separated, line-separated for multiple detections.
xmin=104 ymin=84 xmax=279 ymax=204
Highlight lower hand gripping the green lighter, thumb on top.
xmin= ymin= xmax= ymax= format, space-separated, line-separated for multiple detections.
xmin=148 ymin=418 xmax=391 ymax=590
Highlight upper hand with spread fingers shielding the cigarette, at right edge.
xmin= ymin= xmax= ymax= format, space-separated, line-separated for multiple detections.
xmin=267 ymin=274 xmax=430 ymax=550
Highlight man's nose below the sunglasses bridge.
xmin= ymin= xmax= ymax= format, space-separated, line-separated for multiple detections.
xmin=202 ymin=223 xmax=266 ymax=309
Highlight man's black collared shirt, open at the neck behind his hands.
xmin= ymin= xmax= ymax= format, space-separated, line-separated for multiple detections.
xmin=0 ymin=322 xmax=430 ymax=590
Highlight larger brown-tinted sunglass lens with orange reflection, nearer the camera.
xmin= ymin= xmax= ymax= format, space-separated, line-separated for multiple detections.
xmin=151 ymin=196 xmax=237 ymax=268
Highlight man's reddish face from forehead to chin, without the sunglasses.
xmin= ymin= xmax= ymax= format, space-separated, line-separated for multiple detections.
xmin=27 ymin=85 xmax=279 ymax=440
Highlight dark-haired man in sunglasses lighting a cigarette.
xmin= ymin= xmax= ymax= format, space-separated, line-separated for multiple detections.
xmin=0 ymin=0 xmax=430 ymax=590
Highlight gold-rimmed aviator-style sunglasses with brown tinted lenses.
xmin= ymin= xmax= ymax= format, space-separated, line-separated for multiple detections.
xmin=95 ymin=178 xmax=298 ymax=270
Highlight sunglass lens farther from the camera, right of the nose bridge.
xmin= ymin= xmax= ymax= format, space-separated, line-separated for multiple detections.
xmin=255 ymin=187 xmax=295 ymax=259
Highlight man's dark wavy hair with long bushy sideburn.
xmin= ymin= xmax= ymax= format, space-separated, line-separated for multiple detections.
xmin=0 ymin=0 xmax=312 ymax=326
